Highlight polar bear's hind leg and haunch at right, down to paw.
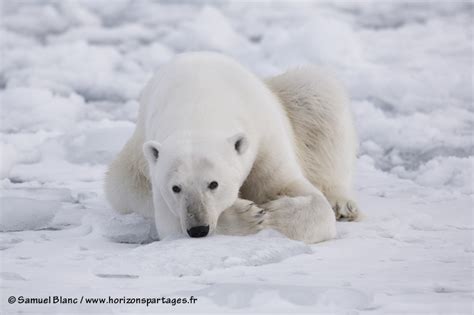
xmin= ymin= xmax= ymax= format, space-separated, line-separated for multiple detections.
xmin=266 ymin=66 xmax=359 ymax=221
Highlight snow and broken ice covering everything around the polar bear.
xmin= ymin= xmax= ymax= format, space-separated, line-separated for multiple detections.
xmin=0 ymin=0 xmax=474 ymax=314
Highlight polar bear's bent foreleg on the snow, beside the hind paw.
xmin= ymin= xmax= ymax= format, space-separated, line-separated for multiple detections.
xmin=261 ymin=178 xmax=336 ymax=243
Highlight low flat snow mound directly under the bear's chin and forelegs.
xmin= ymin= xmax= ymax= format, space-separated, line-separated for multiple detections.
xmin=96 ymin=231 xmax=312 ymax=277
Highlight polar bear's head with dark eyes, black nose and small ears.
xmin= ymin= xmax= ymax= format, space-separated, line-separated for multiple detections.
xmin=143 ymin=133 xmax=250 ymax=237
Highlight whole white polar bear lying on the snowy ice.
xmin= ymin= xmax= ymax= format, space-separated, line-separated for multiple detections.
xmin=105 ymin=52 xmax=359 ymax=243
